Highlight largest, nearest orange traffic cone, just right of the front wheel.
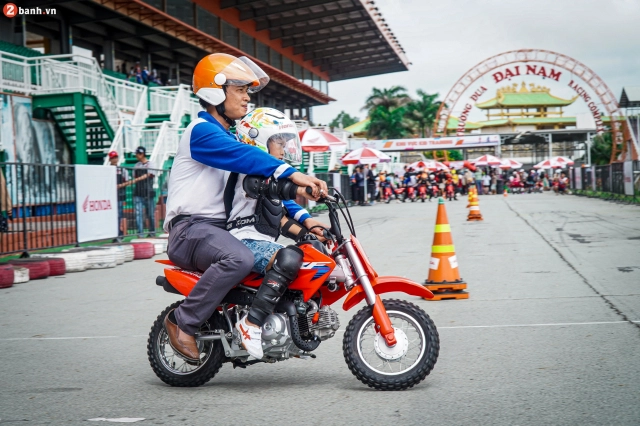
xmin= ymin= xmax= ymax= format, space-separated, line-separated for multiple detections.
xmin=424 ymin=198 xmax=469 ymax=300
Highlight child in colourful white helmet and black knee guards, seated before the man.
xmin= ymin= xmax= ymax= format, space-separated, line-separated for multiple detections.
xmin=230 ymin=108 xmax=326 ymax=359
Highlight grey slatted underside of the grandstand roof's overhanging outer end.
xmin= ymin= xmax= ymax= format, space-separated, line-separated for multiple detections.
xmin=220 ymin=0 xmax=409 ymax=81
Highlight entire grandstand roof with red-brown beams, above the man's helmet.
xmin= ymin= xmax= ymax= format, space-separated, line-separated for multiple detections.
xmin=21 ymin=0 xmax=409 ymax=106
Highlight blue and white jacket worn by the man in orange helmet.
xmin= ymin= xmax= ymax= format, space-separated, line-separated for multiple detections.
xmin=164 ymin=111 xmax=310 ymax=232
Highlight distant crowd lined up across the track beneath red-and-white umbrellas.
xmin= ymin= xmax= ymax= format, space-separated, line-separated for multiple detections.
xmin=350 ymin=165 xmax=569 ymax=205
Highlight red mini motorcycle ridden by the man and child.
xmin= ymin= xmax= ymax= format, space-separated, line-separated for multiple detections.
xmin=147 ymin=191 xmax=440 ymax=390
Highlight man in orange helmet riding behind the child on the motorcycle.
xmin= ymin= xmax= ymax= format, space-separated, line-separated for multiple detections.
xmin=164 ymin=53 xmax=327 ymax=361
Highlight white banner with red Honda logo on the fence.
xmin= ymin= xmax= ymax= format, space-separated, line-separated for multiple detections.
xmin=76 ymin=165 xmax=118 ymax=243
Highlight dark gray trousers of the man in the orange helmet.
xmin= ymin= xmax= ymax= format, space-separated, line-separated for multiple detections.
xmin=167 ymin=216 xmax=253 ymax=336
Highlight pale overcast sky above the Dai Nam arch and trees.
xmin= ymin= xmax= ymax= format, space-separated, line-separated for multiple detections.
xmin=313 ymin=0 xmax=640 ymax=124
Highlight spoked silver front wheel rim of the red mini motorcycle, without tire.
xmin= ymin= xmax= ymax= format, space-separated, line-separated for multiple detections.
xmin=357 ymin=311 xmax=427 ymax=376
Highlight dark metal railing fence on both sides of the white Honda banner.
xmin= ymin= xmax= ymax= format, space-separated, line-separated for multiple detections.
xmin=0 ymin=163 xmax=169 ymax=254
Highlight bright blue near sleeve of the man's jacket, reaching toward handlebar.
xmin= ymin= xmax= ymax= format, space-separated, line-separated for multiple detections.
xmin=190 ymin=123 xmax=296 ymax=179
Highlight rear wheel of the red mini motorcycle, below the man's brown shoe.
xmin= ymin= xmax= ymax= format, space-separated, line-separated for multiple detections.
xmin=147 ymin=301 xmax=225 ymax=387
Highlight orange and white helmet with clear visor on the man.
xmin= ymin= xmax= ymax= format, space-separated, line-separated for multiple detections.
xmin=193 ymin=53 xmax=269 ymax=105
